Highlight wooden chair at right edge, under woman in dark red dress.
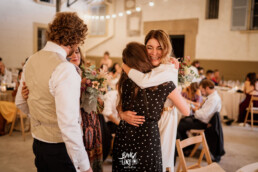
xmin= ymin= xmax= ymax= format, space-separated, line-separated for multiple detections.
xmin=244 ymin=95 xmax=258 ymax=129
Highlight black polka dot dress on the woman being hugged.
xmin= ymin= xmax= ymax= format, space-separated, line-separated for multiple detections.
xmin=112 ymin=79 xmax=175 ymax=172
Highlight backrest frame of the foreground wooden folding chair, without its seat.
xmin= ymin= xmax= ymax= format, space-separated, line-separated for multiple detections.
xmin=176 ymin=132 xmax=212 ymax=172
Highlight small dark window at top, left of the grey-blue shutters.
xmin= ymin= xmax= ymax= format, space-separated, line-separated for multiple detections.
xmin=206 ymin=0 xmax=219 ymax=19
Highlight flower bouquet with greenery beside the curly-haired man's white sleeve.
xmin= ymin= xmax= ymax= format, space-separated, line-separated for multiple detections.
xmin=80 ymin=62 xmax=107 ymax=113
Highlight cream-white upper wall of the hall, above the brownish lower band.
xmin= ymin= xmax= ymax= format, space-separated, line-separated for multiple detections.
xmin=0 ymin=0 xmax=258 ymax=67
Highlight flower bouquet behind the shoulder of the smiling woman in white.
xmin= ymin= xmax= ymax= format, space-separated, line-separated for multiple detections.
xmin=178 ymin=56 xmax=199 ymax=87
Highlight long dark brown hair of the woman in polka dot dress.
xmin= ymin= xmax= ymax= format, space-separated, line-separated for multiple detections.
xmin=117 ymin=42 xmax=153 ymax=109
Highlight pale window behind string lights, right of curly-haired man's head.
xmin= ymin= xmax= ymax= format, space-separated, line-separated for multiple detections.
xmin=90 ymin=4 xmax=106 ymax=36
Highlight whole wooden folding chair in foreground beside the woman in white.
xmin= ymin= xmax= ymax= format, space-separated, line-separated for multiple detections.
xmin=176 ymin=132 xmax=225 ymax=172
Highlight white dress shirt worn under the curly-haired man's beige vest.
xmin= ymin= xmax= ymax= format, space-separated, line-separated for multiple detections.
xmin=15 ymin=41 xmax=90 ymax=171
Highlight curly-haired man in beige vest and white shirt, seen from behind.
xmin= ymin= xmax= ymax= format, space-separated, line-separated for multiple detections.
xmin=15 ymin=12 xmax=92 ymax=172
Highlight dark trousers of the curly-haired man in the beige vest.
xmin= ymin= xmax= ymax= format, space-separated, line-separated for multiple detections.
xmin=33 ymin=139 xmax=76 ymax=172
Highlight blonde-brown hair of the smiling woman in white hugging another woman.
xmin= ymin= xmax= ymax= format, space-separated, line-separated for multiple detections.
xmin=144 ymin=30 xmax=173 ymax=64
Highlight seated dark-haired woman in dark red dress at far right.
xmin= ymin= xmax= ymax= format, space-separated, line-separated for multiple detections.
xmin=237 ymin=73 xmax=258 ymax=123
